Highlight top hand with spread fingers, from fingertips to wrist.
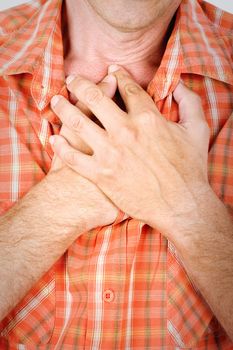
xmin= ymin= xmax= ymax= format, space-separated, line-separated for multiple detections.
xmin=50 ymin=69 xmax=210 ymax=236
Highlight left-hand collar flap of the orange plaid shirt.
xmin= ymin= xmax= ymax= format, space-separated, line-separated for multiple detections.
xmin=0 ymin=0 xmax=68 ymax=124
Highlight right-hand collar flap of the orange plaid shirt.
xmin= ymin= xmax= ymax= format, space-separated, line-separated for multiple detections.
xmin=148 ymin=0 xmax=233 ymax=101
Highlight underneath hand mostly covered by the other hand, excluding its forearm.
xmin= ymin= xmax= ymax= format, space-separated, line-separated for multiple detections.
xmin=50 ymin=76 xmax=118 ymax=228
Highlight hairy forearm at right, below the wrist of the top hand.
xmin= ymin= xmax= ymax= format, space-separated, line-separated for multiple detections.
xmin=174 ymin=192 xmax=233 ymax=340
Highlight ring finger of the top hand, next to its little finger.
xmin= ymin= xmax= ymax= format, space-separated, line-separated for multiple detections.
xmin=51 ymin=95 xmax=107 ymax=151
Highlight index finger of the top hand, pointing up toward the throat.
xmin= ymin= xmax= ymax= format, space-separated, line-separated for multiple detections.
xmin=109 ymin=66 xmax=160 ymax=115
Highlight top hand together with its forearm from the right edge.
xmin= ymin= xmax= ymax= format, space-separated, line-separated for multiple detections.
xmin=51 ymin=67 xmax=233 ymax=339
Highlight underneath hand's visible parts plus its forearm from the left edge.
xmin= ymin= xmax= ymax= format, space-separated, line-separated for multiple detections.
xmin=0 ymin=74 xmax=118 ymax=320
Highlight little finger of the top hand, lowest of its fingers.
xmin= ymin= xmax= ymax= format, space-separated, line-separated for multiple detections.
xmin=49 ymin=135 xmax=96 ymax=181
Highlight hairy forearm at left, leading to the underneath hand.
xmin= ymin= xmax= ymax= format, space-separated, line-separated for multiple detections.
xmin=0 ymin=170 xmax=93 ymax=319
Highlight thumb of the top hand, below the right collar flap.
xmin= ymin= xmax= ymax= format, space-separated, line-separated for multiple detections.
xmin=173 ymin=82 xmax=206 ymax=129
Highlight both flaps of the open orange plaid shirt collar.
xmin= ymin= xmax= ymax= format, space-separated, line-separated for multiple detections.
xmin=0 ymin=0 xmax=233 ymax=106
